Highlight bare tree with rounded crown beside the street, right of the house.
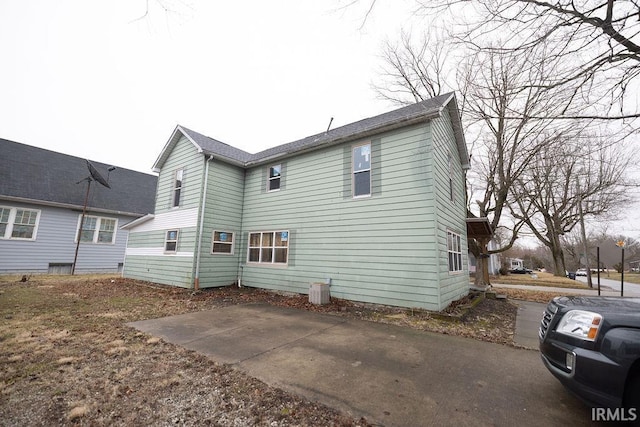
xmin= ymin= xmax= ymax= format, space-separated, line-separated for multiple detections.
xmin=511 ymin=132 xmax=630 ymax=276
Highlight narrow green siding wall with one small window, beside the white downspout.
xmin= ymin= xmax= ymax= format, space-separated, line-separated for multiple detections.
xmin=195 ymin=159 xmax=245 ymax=288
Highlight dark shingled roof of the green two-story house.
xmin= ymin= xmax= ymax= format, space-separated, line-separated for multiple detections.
xmin=154 ymin=93 xmax=468 ymax=172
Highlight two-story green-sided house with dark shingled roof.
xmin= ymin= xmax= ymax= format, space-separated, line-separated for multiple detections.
xmin=122 ymin=94 xmax=469 ymax=310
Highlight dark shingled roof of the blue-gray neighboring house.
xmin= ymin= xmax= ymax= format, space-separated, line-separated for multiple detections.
xmin=0 ymin=139 xmax=158 ymax=215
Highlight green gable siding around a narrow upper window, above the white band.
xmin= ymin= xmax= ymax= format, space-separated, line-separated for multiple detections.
xmin=155 ymin=136 xmax=204 ymax=214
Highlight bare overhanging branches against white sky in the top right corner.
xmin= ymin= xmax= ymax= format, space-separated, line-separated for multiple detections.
xmin=418 ymin=0 xmax=640 ymax=120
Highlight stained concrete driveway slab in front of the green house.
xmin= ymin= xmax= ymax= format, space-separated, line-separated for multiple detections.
xmin=130 ymin=304 xmax=592 ymax=426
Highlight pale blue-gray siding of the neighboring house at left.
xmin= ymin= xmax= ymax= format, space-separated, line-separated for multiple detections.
xmin=0 ymin=200 xmax=135 ymax=273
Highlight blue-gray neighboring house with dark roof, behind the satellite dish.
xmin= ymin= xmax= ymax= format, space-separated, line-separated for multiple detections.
xmin=0 ymin=139 xmax=157 ymax=274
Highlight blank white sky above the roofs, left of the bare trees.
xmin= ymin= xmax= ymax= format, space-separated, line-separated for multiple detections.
xmin=0 ymin=0 xmax=418 ymax=172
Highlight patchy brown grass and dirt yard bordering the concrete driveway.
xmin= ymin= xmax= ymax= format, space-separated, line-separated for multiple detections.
xmin=0 ymin=276 xmax=516 ymax=426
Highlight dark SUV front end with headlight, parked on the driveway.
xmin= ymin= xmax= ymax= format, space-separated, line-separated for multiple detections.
xmin=538 ymin=296 xmax=640 ymax=415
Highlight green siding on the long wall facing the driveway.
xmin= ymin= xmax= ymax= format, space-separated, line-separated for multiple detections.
xmin=241 ymin=124 xmax=441 ymax=310
